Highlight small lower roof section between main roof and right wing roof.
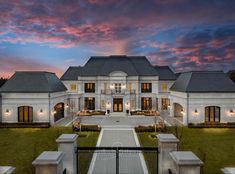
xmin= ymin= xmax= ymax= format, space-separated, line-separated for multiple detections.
xmin=155 ymin=66 xmax=177 ymax=80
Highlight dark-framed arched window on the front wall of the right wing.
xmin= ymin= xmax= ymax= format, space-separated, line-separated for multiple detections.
xmin=205 ymin=106 xmax=220 ymax=122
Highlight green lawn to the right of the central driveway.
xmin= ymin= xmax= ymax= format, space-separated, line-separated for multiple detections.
xmin=138 ymin=127 xmax=235 ymax=174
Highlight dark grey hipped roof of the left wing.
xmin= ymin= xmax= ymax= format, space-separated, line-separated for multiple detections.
xmin=0 ymin=71 xmax=67 ymax=93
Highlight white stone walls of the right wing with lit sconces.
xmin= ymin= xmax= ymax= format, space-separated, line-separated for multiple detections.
xmin=170 ymin=91 xmax=235 ymax=125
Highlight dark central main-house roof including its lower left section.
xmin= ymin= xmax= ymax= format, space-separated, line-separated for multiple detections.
xmin=61 ymin=55 xmax=158 ymax=80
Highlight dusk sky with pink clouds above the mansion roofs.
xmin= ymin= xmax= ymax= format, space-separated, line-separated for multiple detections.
xmin=0 ymin=0 xmax=235 ymax=77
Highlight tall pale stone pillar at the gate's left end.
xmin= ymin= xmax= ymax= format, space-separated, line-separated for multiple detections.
xmin=56 ymin=134 xmax=78 ymax=174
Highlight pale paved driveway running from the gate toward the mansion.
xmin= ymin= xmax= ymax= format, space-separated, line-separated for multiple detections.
xmin=88 ymin=128 xmax=148 ymax=174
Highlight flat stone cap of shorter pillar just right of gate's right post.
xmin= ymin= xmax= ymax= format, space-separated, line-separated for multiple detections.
xmin=170 ymin=151 xmax=203 ymax=166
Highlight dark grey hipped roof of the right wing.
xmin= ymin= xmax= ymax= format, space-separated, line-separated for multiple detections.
xmin=171 ymin=71 xmax=235 ymax=93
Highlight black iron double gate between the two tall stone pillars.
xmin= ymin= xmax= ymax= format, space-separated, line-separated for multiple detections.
xmin=76 ymin=147 xmax=158 ymax=174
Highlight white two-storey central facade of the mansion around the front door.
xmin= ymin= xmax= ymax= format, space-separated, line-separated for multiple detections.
xmin=63 ymin=71 xmax=174 ymax=112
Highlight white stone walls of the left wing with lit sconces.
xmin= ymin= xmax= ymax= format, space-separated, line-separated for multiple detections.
xmin=1 ymin=92 xmax=68 ymax=124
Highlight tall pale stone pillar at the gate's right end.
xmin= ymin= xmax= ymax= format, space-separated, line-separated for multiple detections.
xmin=157 ymin=134 xmax=179 ymax=174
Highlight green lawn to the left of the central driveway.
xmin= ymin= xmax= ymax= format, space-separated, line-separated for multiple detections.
xmin=0 ymin=127 xmax=99 ymax=174
